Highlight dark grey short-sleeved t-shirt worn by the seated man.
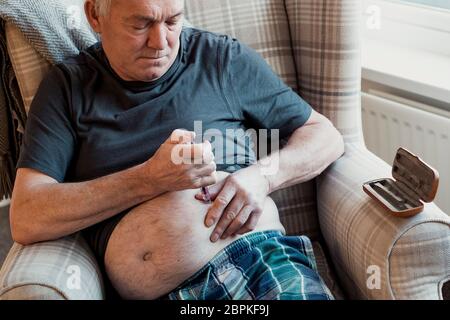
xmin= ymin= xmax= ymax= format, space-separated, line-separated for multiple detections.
xmin=17 ymin=28 xmax=312 ymax=182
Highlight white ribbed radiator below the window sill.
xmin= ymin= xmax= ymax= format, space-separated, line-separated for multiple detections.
xmin=362 ymin=91 xmax=450 ymax=215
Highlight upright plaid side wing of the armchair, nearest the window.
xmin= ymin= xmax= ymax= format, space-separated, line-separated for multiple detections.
xmin=286 ymin=0 xmax=363 ymax=143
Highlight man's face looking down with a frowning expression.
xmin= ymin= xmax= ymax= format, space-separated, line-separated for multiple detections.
xmin=99 ymin=0 xmax=184 ymax=82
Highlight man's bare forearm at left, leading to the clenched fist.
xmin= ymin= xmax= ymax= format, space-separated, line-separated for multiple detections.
xmin=11 ymin=165 xmax=162 ymax=243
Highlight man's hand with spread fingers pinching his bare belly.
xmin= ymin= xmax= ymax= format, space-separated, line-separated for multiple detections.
xmin=195 ymin=165 xmax=270 ymax=242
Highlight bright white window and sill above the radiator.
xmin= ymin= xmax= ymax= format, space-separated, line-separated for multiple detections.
xmin=362 ymin=0 xmax=450 ymax=104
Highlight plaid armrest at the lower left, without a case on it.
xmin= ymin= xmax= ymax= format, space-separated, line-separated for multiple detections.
xmin=0 ymin=233 xmax=104 ymax=300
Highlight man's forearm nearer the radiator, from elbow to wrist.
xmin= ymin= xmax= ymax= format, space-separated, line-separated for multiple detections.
xmin=257 ymin=122 xmax=344 ymax=193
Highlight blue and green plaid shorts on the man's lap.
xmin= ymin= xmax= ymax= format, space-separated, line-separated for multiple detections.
xmin=165 ymin=231 xmax=333 ymax=300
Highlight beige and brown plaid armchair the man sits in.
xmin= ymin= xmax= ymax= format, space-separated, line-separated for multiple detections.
xmin=0 ymin=0 xmax=450 ymax=299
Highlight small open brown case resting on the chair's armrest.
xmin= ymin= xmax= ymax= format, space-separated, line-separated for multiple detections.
xmin=363 ymin=148 xmax=439 ymax=217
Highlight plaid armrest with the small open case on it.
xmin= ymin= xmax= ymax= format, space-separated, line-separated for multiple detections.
xmin=316 ymin=144 xmax=450 ymax=299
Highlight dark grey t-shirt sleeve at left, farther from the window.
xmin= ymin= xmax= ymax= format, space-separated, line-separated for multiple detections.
xmin=17 ymin=66 xmax=76 ymax=182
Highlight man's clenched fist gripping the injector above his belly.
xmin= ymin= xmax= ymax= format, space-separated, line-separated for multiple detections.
xmin=144 ymin=129 xmax=217 ymax=193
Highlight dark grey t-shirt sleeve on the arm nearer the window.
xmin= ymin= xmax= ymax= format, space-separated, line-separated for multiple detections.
xmin=224 ymin=39 xmax=312 ymax=139
